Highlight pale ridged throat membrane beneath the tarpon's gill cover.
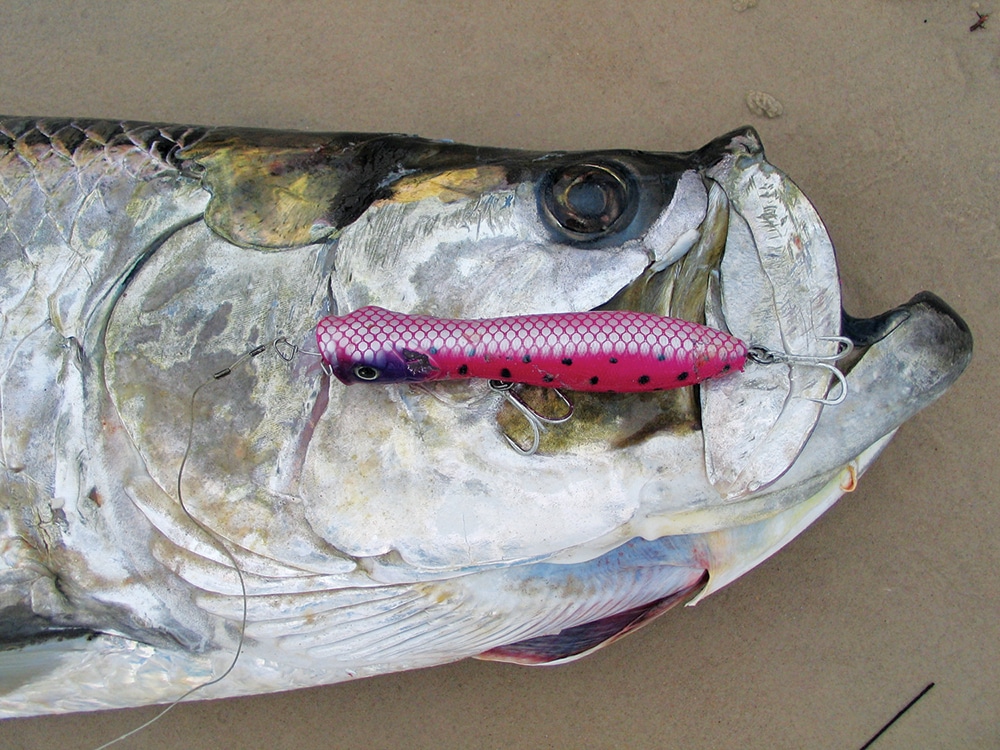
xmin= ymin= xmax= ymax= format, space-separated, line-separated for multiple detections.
xmin=196 ymin=537 xmax=707 ymax=672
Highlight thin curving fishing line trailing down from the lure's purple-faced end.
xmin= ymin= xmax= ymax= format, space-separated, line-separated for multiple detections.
xmin=94 ymin=344 xmax=276 ymax=750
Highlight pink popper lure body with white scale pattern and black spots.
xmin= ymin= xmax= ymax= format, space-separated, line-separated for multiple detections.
xmin=316 ymin=307 xmax=747 ymax=393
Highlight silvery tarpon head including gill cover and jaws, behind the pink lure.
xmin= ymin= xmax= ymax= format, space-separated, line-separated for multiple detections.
xmin=105 ymin=128 xmax=971 ymax=580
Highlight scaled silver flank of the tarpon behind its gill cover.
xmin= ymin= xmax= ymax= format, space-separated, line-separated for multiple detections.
xmin=0 ymin=118 xmax=213 ymax=652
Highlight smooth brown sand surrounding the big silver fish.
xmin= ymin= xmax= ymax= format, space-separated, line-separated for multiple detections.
xmin=0 ymin=0 xmax=1000 ymax=750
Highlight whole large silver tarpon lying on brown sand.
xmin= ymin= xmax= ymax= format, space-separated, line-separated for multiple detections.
xmin=0 ymin=118 xmax=972 ymax=716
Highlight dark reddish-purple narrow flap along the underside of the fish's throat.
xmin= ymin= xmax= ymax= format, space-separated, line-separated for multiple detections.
xmin=476 ymin=570 xmax=709 ymax=666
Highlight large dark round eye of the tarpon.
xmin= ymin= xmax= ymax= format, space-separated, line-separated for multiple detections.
xmin=541 ymin=163 xmax=636 ymax=240
